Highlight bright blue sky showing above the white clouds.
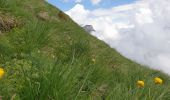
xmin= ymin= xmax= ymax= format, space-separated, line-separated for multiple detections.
xmin=48 ymin=0 xmax=136 ymax=11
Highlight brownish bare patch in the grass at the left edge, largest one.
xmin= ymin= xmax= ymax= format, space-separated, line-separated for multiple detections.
xmin=0 ymin=13 xmax=17 ymax=32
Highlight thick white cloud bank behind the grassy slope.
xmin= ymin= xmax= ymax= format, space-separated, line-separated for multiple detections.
xmin=66 ymin=0 xmax=170 ymax=74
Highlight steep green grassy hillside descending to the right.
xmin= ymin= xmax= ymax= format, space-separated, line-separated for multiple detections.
xmin=0 ymin=0 xmax=170 ymax=100
